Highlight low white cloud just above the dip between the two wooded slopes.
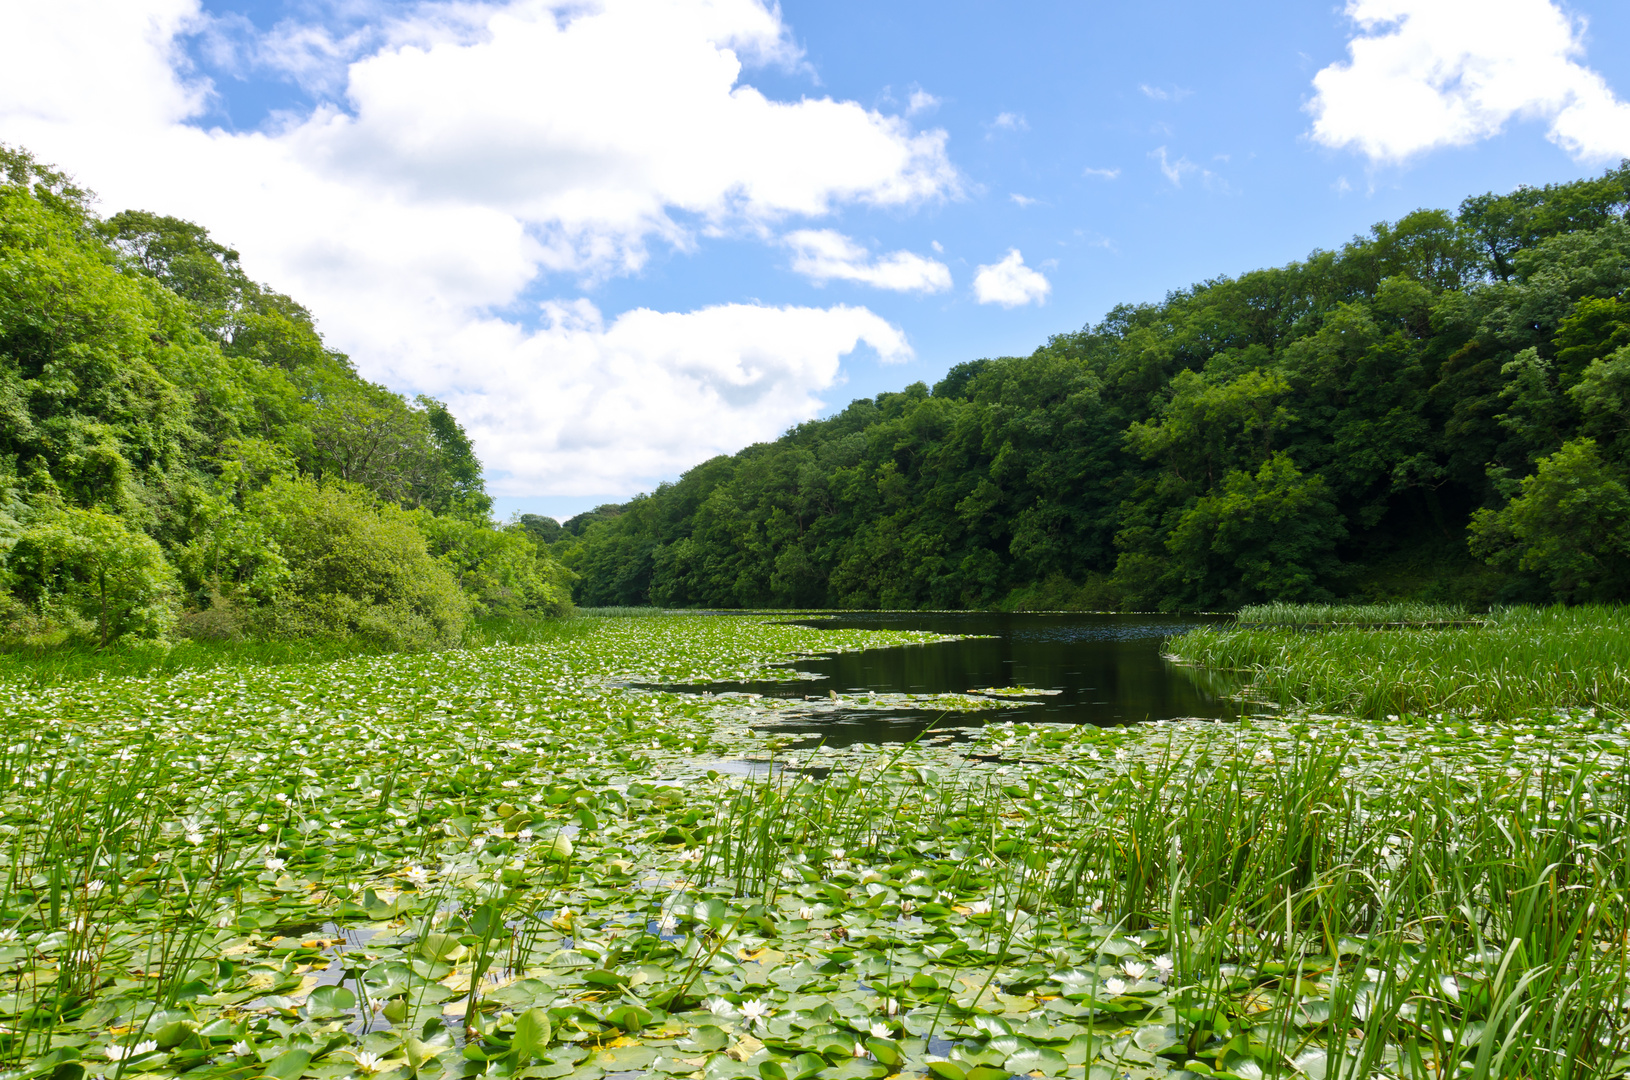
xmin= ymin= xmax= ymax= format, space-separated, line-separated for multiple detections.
xmin=443 ymin=300 xmax=911 ymax=495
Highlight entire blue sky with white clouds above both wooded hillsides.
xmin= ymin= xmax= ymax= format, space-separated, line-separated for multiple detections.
xmin=0 ymin=0 xmax=1630 ymax=516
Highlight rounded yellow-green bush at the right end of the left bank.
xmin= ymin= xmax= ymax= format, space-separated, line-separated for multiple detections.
xmin=243 ymin=477 xmax=469 ymax=648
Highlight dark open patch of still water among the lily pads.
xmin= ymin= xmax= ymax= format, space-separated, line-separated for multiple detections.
xmin=661 ymin=611 xmax=1239 ymax=744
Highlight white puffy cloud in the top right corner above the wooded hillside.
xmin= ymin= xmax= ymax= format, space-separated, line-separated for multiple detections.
xmin=1307 ymin=0 xmax=1630 ymax=163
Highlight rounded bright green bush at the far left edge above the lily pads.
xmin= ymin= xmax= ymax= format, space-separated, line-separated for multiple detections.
xmin=5 ymin=502 xmax=179 ymax=645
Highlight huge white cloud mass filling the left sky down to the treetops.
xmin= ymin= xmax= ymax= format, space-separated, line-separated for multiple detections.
xmin=0 ymin=0 xmax=960 ymax=494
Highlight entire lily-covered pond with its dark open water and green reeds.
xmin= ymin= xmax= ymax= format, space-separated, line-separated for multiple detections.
xmin=0 ymin=608 xmax=1630 ymax=1080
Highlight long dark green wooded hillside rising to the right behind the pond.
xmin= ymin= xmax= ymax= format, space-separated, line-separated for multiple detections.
xmin=551 ymin=161 xmax=1630 ymax=609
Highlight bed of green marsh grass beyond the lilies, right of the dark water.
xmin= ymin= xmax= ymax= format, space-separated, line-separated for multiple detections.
xmin=1169 ymin=606 xmax=1630 ymax=718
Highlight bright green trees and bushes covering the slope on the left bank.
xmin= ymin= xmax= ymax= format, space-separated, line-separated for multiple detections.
xmin=0 ymin=145 xmax=571 ymax=647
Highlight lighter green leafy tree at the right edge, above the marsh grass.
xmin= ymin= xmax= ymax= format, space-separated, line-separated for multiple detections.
xmin=1472 ymin=438 xmax=1630 ymax=601
